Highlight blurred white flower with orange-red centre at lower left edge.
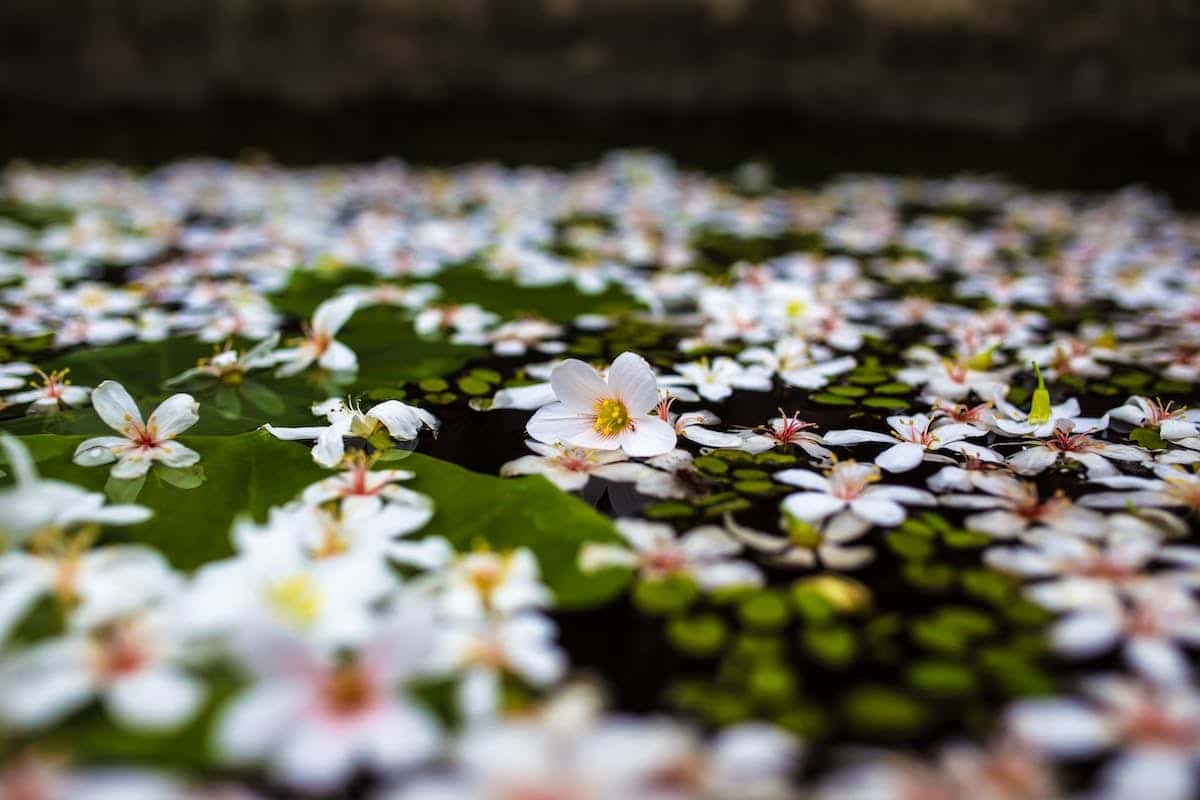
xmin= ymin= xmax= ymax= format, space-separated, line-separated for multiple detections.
xmin=0 ymin=612 xmax=205 ymax=730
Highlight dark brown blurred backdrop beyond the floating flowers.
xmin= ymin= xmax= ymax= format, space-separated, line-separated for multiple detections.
xmin=0 ymin=0 xmax=1200 ymax=205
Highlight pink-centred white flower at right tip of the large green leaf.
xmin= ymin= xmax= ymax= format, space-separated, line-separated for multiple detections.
xmin=580 ymin=519 xmax=764 ymax=590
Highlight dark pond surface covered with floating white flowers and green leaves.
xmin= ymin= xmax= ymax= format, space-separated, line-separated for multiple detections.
xmin=0 ymin=151 xmax=1200 ymax=800
